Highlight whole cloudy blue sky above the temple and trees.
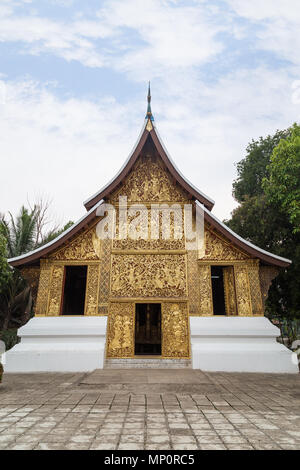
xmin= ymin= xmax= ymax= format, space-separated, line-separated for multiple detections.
xmin=0 ymin=0 xmax=300 ymax=226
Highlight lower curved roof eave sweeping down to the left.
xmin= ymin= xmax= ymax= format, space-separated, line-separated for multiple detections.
xmin=7 ymin=199 xmax=104 ymax=266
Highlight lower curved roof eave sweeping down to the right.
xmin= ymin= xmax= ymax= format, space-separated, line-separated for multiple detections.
xmin=196 ymin=201 xmax=292 ymax=267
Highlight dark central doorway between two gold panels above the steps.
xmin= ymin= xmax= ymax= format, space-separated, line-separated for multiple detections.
xmin=135 ymin=304 xmax=161 ymax=356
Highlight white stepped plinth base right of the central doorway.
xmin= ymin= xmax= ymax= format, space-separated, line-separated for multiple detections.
xmin=190 ymin=317 xmax=299 ymax=374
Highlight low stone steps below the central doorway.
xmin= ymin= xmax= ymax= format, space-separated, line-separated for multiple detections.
xmin=104 ymin=358 xmax=192 ymax=369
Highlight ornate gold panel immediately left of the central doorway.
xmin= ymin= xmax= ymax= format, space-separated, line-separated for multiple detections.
xmin=106 ymin=302 xmax=135 ymax=358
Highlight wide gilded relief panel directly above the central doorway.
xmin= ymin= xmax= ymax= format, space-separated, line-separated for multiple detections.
xmin=111 ymin=254 xmax=187 ymax=297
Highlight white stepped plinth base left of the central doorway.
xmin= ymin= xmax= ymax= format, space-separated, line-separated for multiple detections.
xmin=4 ymin=317 xmax=107 ymax=372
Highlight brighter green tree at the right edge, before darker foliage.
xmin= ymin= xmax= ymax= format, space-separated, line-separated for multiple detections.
xmin=262 ymin=124 xmax=300 ymax=232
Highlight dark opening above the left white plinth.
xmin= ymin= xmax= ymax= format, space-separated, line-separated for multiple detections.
xmin=61 ymin=266 xmax=87 ymax=315
